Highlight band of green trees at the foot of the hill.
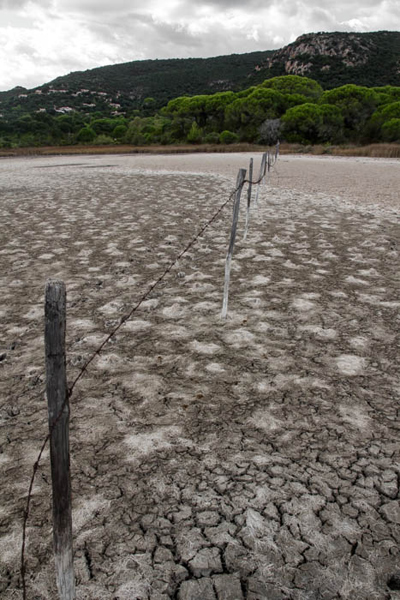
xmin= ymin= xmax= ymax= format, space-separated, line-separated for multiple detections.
xmin=0 ymin=75 xmax=400 ymax=148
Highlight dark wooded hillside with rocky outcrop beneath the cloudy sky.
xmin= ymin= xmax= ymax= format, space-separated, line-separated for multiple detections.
xmin=0 ymin=31 xmax=400 ymax=116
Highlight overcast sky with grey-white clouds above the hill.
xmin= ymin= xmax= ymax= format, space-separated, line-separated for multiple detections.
xmin=0 ymin=0 xmax=400 ymax=90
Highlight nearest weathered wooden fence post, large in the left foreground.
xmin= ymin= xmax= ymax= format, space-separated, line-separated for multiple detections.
xmin=45 ymin=281 xmax=75 ymax=600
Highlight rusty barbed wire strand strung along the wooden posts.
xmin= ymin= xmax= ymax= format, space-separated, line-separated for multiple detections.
xmin=20 ymin=157 xmax=277 ymax=600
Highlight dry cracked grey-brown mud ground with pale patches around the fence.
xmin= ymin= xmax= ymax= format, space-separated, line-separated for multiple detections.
xmin=0 ymin=156 xmax=400 ymax=600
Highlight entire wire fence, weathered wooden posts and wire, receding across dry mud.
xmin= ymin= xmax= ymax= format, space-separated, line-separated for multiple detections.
xmin=21 ymin=154 xmax=278 ymax=600
